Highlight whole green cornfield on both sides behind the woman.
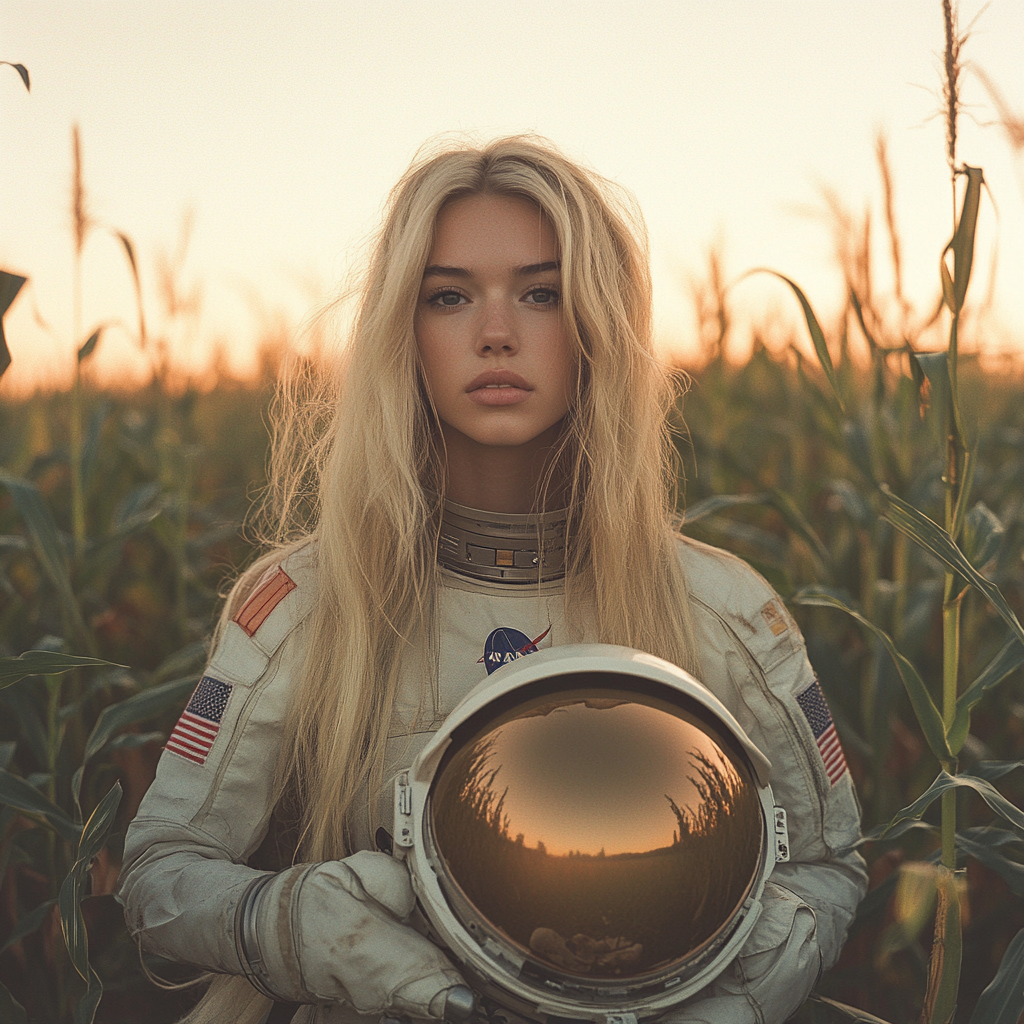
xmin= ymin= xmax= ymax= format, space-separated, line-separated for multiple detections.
xmin=0 ymin=3 xmax=1024 ymax=1024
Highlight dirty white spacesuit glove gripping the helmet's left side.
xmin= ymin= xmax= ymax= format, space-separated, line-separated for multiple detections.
xmin=236 ymin=851 xmax=465 ymax=1020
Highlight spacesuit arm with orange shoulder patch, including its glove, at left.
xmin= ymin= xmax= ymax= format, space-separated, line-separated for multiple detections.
xmin=118 ymin=552 xmax=463 ymax=1018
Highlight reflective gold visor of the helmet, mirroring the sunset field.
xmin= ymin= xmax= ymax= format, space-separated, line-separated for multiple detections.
xmin=428 ymin=674 xmax=764 ymax=981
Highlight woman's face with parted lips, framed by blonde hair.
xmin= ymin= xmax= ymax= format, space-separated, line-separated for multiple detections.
xmin=416 ymin=196 xmax=575 ymax=456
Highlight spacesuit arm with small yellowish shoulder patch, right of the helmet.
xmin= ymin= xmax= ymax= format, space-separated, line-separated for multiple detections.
xmin=664 ymin=541 xmax=866 ymax=1024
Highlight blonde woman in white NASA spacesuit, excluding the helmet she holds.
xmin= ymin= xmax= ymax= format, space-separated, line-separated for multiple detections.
xmin=120 ymin=138 xmax=864 ymax=1024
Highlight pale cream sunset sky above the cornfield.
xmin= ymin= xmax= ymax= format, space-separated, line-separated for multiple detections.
xmin=0 ymin=0 xmax=1024 ymax=393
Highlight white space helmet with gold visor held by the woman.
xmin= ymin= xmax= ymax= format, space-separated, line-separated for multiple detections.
xmin=394 ymin=644 xmax=788 ymax=1024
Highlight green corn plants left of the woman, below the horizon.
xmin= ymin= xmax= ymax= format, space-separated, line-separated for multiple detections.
xmin=0 ymin=378 xmax=269 ymax=1024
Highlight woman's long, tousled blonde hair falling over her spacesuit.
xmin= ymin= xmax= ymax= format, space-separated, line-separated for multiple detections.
xmin=184 ymin=136 xmax=698 ymax=1020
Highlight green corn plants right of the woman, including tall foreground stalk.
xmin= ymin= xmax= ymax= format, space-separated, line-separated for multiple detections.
xmin=686 ymin=142 xmax=1024 ymax=1024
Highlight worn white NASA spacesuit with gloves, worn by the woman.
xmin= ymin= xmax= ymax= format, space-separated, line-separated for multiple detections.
xmin=119 ymin=509 xmax=865 ymax=1024
